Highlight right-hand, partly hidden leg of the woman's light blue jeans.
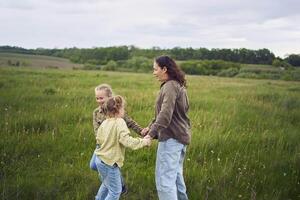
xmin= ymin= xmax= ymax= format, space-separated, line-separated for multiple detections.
xmin=176 ymin=146 xmax=188 ymax=200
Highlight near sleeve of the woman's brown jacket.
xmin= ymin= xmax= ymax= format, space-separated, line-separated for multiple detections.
xmin=149 ymin=82 xmax=178 ymax=138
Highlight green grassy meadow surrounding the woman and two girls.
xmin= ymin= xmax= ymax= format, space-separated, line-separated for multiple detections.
xmin=0 ymin=67 xmax=300 ymax=200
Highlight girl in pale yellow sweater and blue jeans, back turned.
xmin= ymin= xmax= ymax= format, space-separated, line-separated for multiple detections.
xmin=95 ymin=96 xmax=151 ymax=200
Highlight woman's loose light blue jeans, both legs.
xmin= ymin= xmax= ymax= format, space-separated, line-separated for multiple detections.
xmin=155 ymin=138 xmax=188 ymax=200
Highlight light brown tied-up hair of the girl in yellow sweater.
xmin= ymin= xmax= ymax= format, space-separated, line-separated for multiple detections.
xmin=103 ymin=95 xmax=125 ymax=117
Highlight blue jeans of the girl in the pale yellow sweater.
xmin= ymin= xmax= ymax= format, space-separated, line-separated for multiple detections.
xmin=95 ymin=156 xmax=122 ymax=200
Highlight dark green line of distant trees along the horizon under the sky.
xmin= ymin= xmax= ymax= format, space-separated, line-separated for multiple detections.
xmin=0 ymin=46 xmax=300 ymax=66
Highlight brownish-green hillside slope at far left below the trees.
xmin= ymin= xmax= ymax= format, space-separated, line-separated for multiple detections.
xmin=0 ymin=52 xmax=83 ymax=69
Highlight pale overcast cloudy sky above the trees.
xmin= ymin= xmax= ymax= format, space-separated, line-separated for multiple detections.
xmin=0 ymin=0 xmax=300 ymax=58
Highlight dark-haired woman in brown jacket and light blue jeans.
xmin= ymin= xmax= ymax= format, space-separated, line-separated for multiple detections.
xmin=142 ymin=56 xmax=191 ymax=200
